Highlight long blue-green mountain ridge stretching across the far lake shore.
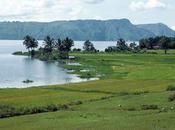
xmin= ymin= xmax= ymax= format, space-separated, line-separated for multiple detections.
xmin=0 ymin=19 xmax=175 ymax=41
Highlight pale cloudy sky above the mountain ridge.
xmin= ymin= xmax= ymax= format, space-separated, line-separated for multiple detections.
xmin=0 ymin=0 xmax=175 ymax=30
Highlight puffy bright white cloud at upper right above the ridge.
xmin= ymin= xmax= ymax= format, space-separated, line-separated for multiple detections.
xmin=130 ymin=0 xmax=166 ymax=11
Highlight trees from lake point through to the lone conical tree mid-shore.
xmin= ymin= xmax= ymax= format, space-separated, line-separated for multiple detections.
xmin=23 ymin=35 xmax=98 ymax=60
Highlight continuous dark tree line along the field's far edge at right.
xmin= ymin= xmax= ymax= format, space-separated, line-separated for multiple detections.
xmin=105 ymin=36 xmax=175 ymax=54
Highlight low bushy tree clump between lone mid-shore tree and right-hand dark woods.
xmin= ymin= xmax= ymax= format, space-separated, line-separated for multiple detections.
xmin=105 ymin=39 xmax=140 ymax=52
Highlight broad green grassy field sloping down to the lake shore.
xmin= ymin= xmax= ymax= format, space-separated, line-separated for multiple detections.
xmin=0 ymin=51 xmax=175 ymax=130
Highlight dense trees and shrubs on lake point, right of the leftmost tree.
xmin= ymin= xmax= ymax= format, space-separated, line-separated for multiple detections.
xmin=21 ymin=36 xmax=74 ymax=61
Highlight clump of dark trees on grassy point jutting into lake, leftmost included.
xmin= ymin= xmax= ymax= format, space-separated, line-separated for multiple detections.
xmin=23 ymin=36 xmax=74 ymax=60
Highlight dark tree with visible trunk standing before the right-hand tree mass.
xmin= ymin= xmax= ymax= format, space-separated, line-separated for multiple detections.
xmin=160 ymin=36 xmax=171 ymax=54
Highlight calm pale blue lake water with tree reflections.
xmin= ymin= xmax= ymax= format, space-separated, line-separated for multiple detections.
xmin=0 ymin=40 xmax=119 ymax=88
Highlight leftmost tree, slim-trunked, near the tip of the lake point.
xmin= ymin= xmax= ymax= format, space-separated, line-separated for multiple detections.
xmin=23 ymin=35 xmax=38 ymax=57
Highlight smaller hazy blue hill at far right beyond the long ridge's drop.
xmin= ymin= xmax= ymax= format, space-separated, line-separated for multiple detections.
xmin=137 ymin=23 xmax=175 ymax=37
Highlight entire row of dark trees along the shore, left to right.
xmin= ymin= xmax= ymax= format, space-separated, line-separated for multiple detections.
xmin=23 ymin=35 xmax=175 ymax=60
